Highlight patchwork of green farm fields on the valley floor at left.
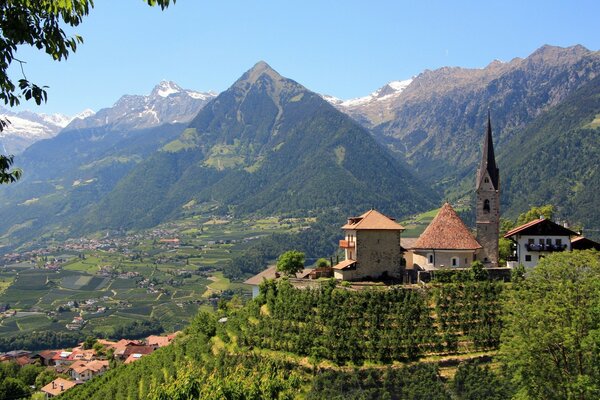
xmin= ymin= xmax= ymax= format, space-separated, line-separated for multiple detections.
xmin=0 ymin=215 xmax=313 ymax=336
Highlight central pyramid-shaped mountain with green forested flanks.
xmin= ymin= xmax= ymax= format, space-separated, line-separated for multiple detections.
xmin=87 ymin=62 xmax=436 ymax=229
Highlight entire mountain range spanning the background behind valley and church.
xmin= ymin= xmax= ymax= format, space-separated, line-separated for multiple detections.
xmin=0 ymin=46 xmax=600 ymax=250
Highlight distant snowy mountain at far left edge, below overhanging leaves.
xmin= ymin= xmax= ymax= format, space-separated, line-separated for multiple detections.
xmin=0 ymin=107 xmax=94 ymax=154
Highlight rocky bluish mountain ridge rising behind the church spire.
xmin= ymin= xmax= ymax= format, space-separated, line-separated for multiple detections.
xmin=338 ymin=45 xmax=600 ymax=191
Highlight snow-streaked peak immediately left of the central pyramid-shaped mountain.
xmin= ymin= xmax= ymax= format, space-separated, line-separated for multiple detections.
xmin=66 ymin=81 xmax=217 ymax=130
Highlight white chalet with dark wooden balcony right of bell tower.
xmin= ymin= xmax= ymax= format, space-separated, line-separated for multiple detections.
xmin=504 ymin=218 xmax=579 ymax=268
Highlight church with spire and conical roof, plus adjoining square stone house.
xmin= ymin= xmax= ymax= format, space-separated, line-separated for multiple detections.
xmin=333 ymin=114 xmax=500 ymax=281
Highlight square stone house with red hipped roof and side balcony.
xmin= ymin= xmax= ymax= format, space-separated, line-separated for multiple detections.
xmin=333 ymin=210 xmax=404 ymax=281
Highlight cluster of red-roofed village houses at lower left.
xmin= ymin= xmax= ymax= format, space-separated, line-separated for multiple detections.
xmin=0 ymin=333 xmax=177 ymax=398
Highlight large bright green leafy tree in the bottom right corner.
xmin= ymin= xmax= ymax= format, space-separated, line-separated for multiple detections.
xmin=501 ymin=250 xmax=600 ymax=400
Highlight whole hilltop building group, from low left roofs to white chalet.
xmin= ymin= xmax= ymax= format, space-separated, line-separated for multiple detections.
xmin=245 ymin=116 xmax=600 ymax=296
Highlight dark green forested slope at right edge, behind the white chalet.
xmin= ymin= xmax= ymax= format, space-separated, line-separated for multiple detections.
xmin=499 ymin=76 xmax=600 ymax=233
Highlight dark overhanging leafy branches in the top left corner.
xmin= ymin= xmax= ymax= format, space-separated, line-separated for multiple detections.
xmin=0 ymin=0 xmax=176 ymax=184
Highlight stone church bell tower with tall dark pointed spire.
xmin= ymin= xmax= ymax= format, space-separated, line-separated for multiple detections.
xmin=475 ymin=111 xmax=500 ymax=268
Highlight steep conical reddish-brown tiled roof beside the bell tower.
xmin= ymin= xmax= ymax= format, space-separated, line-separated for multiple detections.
xmin=412 ymin=203 xmax=481 ymax=250
